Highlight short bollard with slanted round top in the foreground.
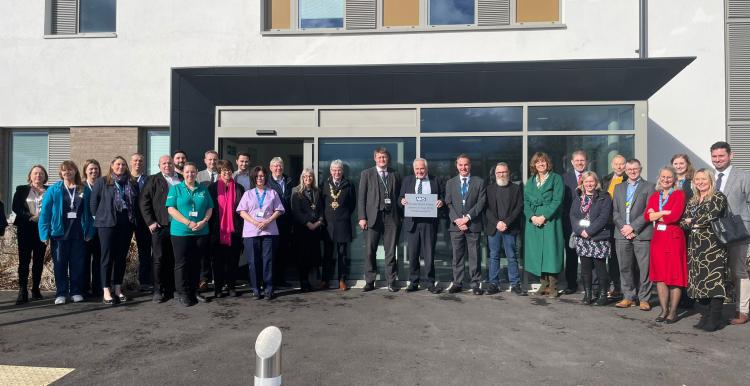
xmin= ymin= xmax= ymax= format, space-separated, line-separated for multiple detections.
xmin=255 ymin=326 xmax=281 ymax=386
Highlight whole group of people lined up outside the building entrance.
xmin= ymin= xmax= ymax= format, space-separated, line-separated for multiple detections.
xmin=7 ymin=142 xmax=750 ymax=331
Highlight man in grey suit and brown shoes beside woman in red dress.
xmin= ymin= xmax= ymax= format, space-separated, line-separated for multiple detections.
xmin=612 ymin=159 xmax=655 ymax=311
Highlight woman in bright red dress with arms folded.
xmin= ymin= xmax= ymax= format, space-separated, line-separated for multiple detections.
xmin=645 ymin=166 xmax=687 ymax=324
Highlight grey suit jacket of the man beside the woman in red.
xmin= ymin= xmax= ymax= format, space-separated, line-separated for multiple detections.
xmin=612 ymin=178 xmax=656 ymax=241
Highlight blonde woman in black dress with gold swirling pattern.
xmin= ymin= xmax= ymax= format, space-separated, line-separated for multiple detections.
xmin=680 ymin=169 xmax=727 ymax=332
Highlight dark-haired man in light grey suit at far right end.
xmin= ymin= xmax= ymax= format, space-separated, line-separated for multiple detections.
xmin=711 ymin=142 xmax=750 ymax=325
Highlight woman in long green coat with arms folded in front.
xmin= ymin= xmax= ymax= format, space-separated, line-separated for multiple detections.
xmin=523 ymin=152 xmax=565 ymax=297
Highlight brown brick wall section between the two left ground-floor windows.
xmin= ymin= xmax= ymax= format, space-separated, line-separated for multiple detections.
xmin=70 ymin=127 xmax=138 ymax=173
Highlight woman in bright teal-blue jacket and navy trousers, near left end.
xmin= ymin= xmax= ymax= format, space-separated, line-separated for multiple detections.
xmin=39 ymin=161 xmax=94 ymax=304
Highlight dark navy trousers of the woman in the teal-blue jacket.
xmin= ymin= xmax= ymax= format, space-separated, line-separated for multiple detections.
xmin=52 ymin=239 xmax=86 ymax=297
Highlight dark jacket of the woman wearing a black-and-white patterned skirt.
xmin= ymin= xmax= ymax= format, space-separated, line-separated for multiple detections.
xmin=569 ymin=190 xmax=612 ymax=241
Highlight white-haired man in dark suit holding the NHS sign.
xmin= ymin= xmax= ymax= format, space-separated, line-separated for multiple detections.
xmin=399 ymin=158 xmax=444 ymax=294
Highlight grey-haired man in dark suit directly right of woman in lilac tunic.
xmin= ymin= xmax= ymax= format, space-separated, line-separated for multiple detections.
xmin=268 ymin=157 xmax=294 ymax=287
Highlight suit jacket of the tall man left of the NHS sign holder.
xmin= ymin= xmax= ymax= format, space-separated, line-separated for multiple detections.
xmin=357 ymin=166 xmax=401 ymax=227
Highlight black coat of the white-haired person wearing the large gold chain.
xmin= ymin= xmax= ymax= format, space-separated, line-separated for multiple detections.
xmin=320 ymin=178 xmax=357 ymax=243
